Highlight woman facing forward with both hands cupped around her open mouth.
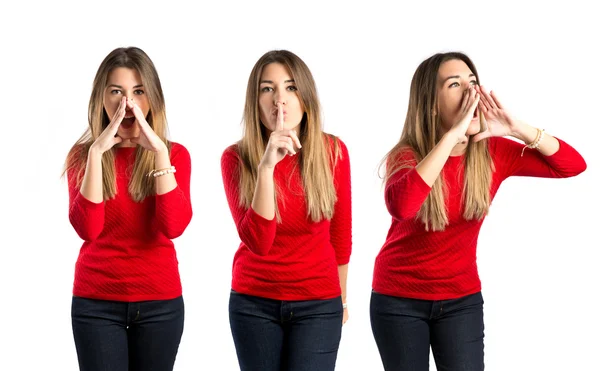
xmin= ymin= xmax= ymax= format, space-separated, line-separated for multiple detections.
xmin=66 ymin=48 xmax=192 ymax=371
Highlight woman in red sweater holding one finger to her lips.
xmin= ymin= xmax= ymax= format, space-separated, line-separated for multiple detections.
xmin=221 ymin=50 xmax=352 ymax=371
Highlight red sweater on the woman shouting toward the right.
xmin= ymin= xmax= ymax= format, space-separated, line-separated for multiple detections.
xmin=373 ymin=138 xmax=586 ymax=300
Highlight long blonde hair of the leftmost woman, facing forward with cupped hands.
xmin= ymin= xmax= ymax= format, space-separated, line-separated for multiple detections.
xmin=63 ymin=47 xmax=171 ymax=202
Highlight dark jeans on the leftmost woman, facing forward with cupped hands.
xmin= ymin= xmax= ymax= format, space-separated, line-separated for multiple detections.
xmin=71 ymin=296 xmax=184 ymax=371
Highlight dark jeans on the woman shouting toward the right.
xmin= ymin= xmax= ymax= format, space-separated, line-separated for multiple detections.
xmin=371 ymin=292 xmax=484 ymax=371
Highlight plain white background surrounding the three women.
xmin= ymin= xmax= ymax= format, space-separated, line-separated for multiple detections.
xmin=0 ymin=0 xmax=600 ymax=371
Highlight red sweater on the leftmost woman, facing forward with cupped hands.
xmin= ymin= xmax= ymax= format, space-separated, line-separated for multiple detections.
xmin=68 ymin=143 xmax=192 ymax=302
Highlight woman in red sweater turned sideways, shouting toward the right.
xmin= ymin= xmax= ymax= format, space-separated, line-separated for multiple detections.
xmin=371 ymin=53 xmax=586 ymax=371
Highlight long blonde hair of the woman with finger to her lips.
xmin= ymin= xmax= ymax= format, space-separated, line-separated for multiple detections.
xmin=238 ymin=50 xmax=340 ymax=222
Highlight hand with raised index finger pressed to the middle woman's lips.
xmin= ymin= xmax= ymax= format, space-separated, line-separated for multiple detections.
xmin=258 ymin=104 xmax=302 ymax=169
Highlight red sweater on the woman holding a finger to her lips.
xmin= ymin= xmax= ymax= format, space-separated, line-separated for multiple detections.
xmin=221 ymin=140 xmax=352 ymax=300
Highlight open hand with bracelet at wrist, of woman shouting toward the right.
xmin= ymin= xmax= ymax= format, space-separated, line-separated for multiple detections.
xmin=473 ymin=86 xmax=519 ymax=142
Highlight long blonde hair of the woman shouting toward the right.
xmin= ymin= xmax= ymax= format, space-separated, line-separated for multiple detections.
xmin=382 ymin=52 xmax=493 ymax=231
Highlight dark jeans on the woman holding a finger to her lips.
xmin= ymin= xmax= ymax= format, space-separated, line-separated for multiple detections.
xmin=229 ymin=290 xmax=343 ymax=371
